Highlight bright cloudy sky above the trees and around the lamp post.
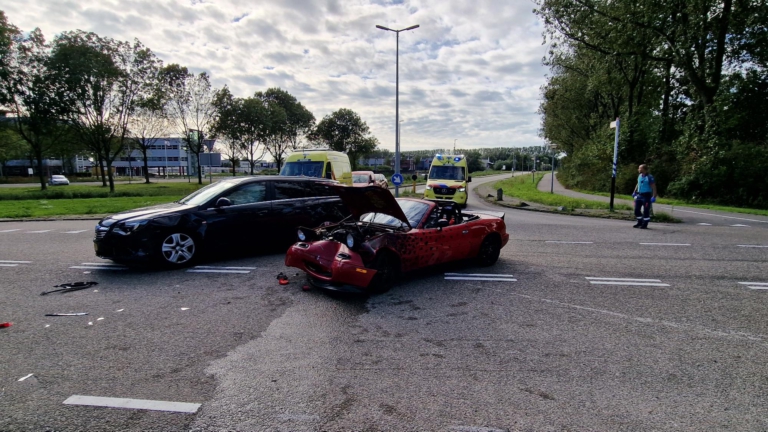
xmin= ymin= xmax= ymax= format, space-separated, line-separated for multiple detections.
xmin=0 ymin=0 xmax=547 ymax=150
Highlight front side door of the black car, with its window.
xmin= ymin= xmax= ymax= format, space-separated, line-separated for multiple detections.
xmin=200 ymin=181 xmax=273 ymax=251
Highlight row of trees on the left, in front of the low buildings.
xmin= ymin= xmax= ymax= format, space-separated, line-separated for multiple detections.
xmin=0 ymin=11 xmax=378 ymax=191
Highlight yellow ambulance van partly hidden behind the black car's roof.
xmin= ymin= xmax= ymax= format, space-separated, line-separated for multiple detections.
xmin=280 ymin=149 xmax=352 ymax=186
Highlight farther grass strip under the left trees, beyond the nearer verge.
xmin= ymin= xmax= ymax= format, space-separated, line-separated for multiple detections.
xmin=0 ymin=182 xmax=205 ymax=201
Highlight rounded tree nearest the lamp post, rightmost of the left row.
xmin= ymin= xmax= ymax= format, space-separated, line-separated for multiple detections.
xmin=309 ymin=108 xmax=379 ymax=167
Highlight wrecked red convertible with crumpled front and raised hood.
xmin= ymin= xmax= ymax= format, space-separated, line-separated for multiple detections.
xmin=285 ymin=186 xmax=509 ymax=294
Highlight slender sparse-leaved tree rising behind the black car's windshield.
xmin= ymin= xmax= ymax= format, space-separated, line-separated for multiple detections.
xmin=160 ymin=64 xmax=216 ymax=184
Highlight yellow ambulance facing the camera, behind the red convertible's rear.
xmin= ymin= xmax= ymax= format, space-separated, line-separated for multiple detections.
xmin=424 ymin=154 xmax=472 ymax=207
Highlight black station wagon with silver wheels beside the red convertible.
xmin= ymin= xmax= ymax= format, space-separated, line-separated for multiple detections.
xmin=93 ymin=176 xmax=349 ymax=266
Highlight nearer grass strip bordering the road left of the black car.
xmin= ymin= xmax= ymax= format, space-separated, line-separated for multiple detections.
xmin=0 ymin=196 xmax=181 ymax=219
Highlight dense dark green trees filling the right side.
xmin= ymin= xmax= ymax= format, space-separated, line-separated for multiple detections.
xmin=535 ymin=0 xmax=768 ymax=208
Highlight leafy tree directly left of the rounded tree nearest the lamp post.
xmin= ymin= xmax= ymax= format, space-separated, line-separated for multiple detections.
xmin=254 ymin=88 xmax=315 ymax=172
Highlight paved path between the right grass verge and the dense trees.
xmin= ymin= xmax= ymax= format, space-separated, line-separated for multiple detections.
xmin=538 ymin=174 xmax=768 ymax=228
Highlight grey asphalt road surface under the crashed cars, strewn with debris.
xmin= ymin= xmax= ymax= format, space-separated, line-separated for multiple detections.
xmin=0 ymin=173 xmax=768 ymax=431
